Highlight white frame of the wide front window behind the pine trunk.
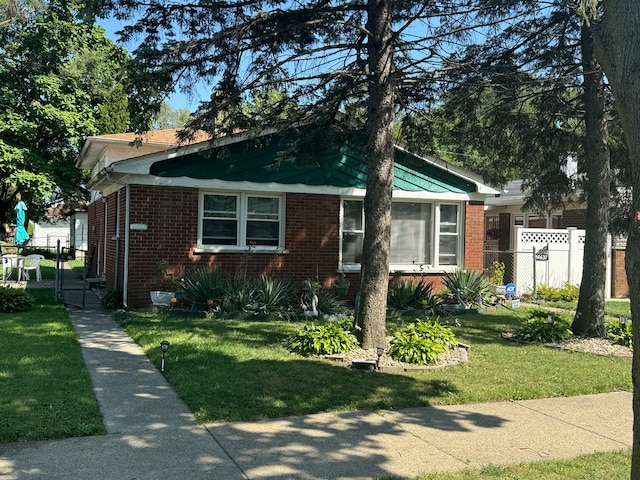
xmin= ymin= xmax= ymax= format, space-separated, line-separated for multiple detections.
xmin=339 ymin=197 xmax=465 ymax=273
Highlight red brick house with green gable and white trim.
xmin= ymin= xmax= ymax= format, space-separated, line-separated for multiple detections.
xmin=76 ymin=130 xmax=497 ymax=307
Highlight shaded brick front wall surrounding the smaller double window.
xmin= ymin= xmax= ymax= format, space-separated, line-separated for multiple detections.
xmin=123 ymin=185 xmax=340 ymax=307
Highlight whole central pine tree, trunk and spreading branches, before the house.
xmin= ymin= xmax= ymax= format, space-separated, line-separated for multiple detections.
xmin=93 ymin=0 xmax=490 ymax=348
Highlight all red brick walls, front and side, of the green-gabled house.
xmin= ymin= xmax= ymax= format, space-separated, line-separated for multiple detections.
xmin=94 ymin=185 xmax=484 ymax=308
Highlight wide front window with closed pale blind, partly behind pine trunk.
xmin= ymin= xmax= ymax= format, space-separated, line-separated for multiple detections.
xmin=341 ymin=199 xmax=461 ymax=271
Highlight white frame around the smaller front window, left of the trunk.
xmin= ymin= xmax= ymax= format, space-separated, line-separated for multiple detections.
xmin=197 ymin=190 xmax=286 ymax=252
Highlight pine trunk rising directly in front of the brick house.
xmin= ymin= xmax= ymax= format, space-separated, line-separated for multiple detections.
xmin=356 ymin=0 xmax=395 ymax=348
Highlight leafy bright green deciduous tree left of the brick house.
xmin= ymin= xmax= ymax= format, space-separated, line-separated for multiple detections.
xmin=0 ymin=2 xmax=128 ymax=231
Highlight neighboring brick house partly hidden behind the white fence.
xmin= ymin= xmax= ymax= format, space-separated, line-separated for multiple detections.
xmin=485 ymin=180 xmax=629 ymax=298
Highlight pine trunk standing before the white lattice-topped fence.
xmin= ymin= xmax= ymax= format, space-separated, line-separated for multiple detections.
xmin=571 ymin=22 xmax=611 ymax=337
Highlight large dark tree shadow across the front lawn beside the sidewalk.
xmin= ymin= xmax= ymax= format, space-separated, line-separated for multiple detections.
xmin=158 ymin=345 xmax=457 ymax=423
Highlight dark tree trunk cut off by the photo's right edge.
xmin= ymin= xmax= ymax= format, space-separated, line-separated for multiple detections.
xmin=596 ymin=0 xmax=640 ymax=480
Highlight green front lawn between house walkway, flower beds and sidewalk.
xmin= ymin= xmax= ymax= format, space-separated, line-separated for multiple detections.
xmin=122 ymin=309 xmax=632 ymax=423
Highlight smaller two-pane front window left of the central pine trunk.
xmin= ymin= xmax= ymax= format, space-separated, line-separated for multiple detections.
xmin=200 ymin=192 xmax=284 ymax=249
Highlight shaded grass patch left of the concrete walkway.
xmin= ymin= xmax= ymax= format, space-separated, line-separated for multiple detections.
xmin=0 ymin=289 xmax=105 ymax=442
